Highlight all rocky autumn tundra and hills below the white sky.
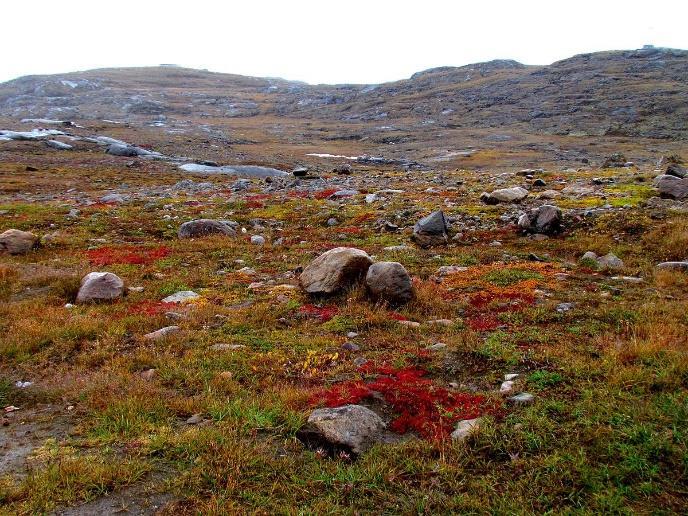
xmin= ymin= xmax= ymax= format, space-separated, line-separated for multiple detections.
xmin=0 ymin=48 xmax=688 ymax=514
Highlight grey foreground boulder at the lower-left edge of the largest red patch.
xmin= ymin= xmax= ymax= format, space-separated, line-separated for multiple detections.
xmin=306 ymin=405 xmax=385 ymax=454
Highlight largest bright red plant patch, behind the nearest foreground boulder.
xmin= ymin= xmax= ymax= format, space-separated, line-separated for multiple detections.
xmin=314 ymin=366 xmax=497 ymax=440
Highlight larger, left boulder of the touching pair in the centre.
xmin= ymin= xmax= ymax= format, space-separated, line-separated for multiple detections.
xmin=299 ymin=247 xmax=373 ymax=294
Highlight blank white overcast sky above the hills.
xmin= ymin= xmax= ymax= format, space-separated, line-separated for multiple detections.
xmin=0 ymin=0 xmax=688 ymax=83
